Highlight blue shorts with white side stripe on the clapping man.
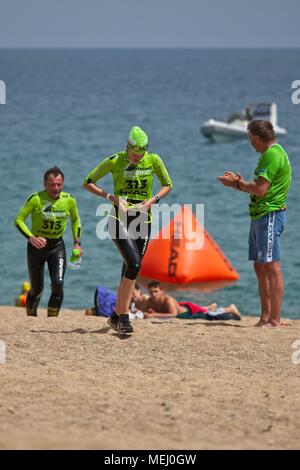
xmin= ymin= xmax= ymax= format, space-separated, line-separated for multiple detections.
xmin=249 ymin=210 xmax=286 ymax=263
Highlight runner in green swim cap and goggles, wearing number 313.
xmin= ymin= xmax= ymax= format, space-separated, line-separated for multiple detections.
xmin=83 ymin=126 xmax=172 ymax=333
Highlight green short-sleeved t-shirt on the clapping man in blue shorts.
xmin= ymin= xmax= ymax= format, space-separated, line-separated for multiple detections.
xmin=249 ymin=144 xmax=292 ymax=220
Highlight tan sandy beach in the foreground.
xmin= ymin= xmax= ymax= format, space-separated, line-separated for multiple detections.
xmin=0 ymin=307 xmax=300 ymax=449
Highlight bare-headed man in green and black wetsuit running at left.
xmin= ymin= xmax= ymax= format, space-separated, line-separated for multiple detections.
xmin=15 ymin=167 xmax=82 ymax=317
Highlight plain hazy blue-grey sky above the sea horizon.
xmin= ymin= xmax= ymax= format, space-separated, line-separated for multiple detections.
xmin=0 ymin=0 xmax=300 ymax=48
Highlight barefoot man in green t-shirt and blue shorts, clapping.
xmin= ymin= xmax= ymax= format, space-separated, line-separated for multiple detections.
xmin=218 ymin=120 xmax=292 ymax=328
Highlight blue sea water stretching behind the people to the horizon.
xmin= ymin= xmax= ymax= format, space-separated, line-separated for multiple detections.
xmin=0 ymin=49 xmax=300 ymax=318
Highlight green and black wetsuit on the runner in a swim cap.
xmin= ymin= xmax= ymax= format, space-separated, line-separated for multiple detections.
xmin=84 ymin=151 xmax=172 ymax=279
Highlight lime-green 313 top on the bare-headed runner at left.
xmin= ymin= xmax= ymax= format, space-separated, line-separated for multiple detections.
xmin=15 ymin=191 xmax=81 ymax=238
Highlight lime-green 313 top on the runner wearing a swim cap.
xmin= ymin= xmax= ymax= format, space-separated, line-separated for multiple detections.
xmin=83 ymin=151 xmax=172 ymax=201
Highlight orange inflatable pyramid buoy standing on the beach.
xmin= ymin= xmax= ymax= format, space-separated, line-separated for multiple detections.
xmin=140 ymin=205 xmax=239 ymax=284
